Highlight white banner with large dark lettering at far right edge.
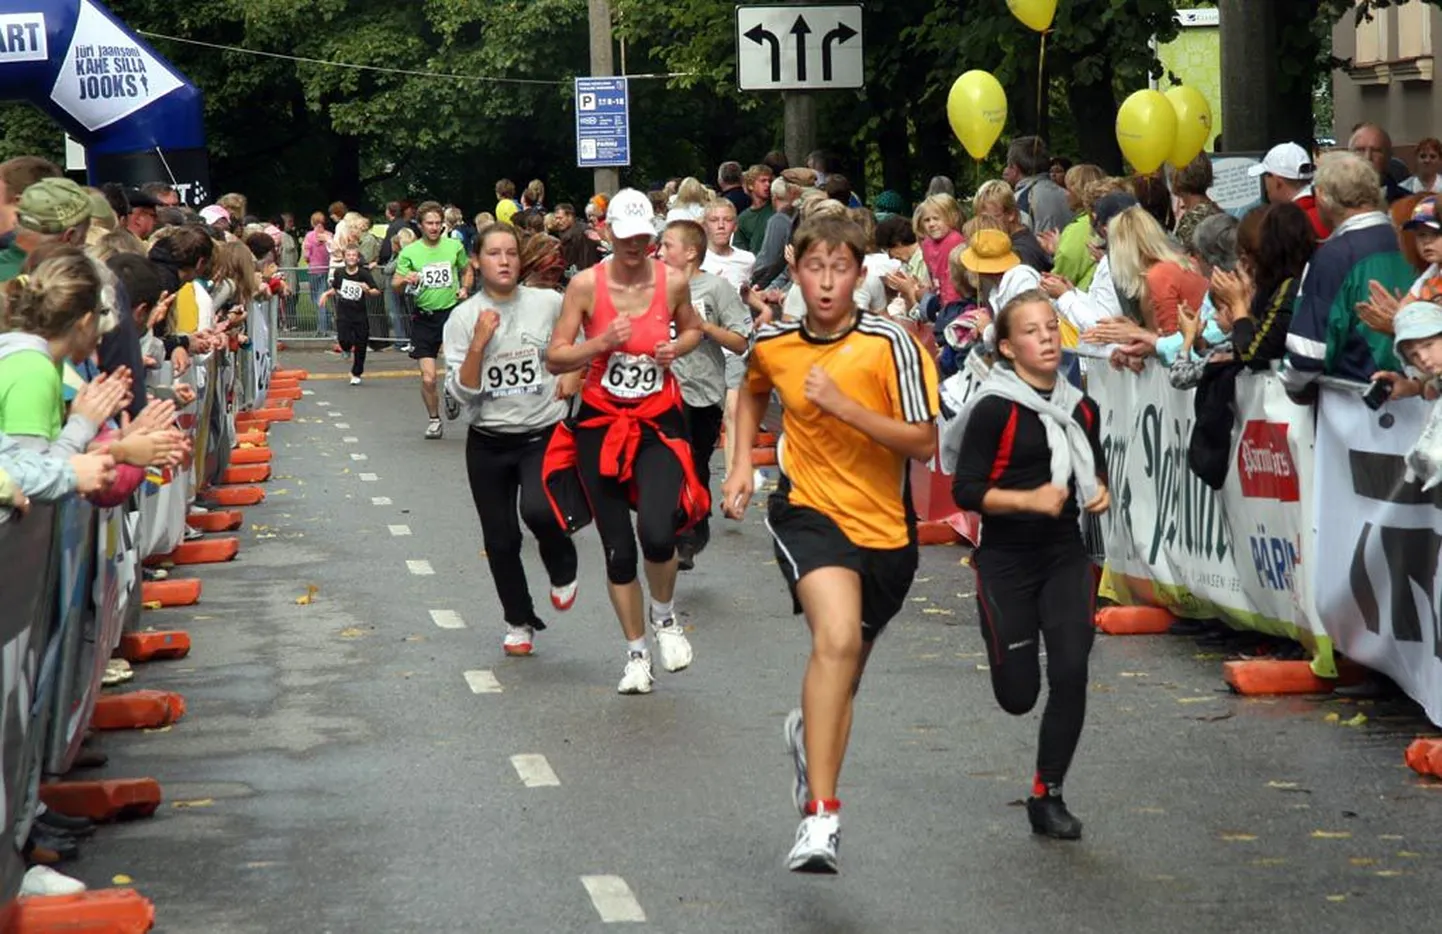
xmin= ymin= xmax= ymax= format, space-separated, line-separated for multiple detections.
xmin=1312 ymin=389 xmax=1442 ymax=724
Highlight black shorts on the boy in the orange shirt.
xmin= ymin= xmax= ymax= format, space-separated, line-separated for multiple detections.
xmin=766 ymin=479 xmax=917 ymax=641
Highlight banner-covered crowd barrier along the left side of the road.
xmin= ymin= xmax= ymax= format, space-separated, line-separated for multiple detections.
xmin=0 ymin=300 xmax=280 ymax=920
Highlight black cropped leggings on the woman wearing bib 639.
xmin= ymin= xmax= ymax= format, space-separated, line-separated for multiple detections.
xmin=575 ymin=405 xmax=686 ymax=584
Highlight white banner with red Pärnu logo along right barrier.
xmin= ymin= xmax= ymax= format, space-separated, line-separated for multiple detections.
xmin=1087 ymin=363 xmax=1335 ymax=676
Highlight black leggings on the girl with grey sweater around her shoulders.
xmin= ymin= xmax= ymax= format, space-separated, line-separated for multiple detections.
xmin=972 ymin=538 xmax=1096 ymax=786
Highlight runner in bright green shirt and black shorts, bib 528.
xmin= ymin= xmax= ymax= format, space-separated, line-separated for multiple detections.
xmin=391 ymin=202 xmax=466 ymax=441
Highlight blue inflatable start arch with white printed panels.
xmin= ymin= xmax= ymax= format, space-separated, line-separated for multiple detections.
xmin=0 ymin=0 xmax=211 ymax=205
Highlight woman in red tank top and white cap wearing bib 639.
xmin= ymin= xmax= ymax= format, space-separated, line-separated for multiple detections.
xmin=544 ymin=189 xmax=711 ymax=693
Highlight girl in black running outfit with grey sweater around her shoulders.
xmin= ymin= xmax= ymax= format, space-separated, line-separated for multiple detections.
xmin=952 ymin=293 xmax=1109 ymax=839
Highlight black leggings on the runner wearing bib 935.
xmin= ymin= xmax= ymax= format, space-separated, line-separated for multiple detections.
xmin=466 ymin=427 xmax=577 ymax=628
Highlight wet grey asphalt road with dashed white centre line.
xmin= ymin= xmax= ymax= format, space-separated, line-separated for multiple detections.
xmin=68 ymin=353 xmax=1442 ymax=934
